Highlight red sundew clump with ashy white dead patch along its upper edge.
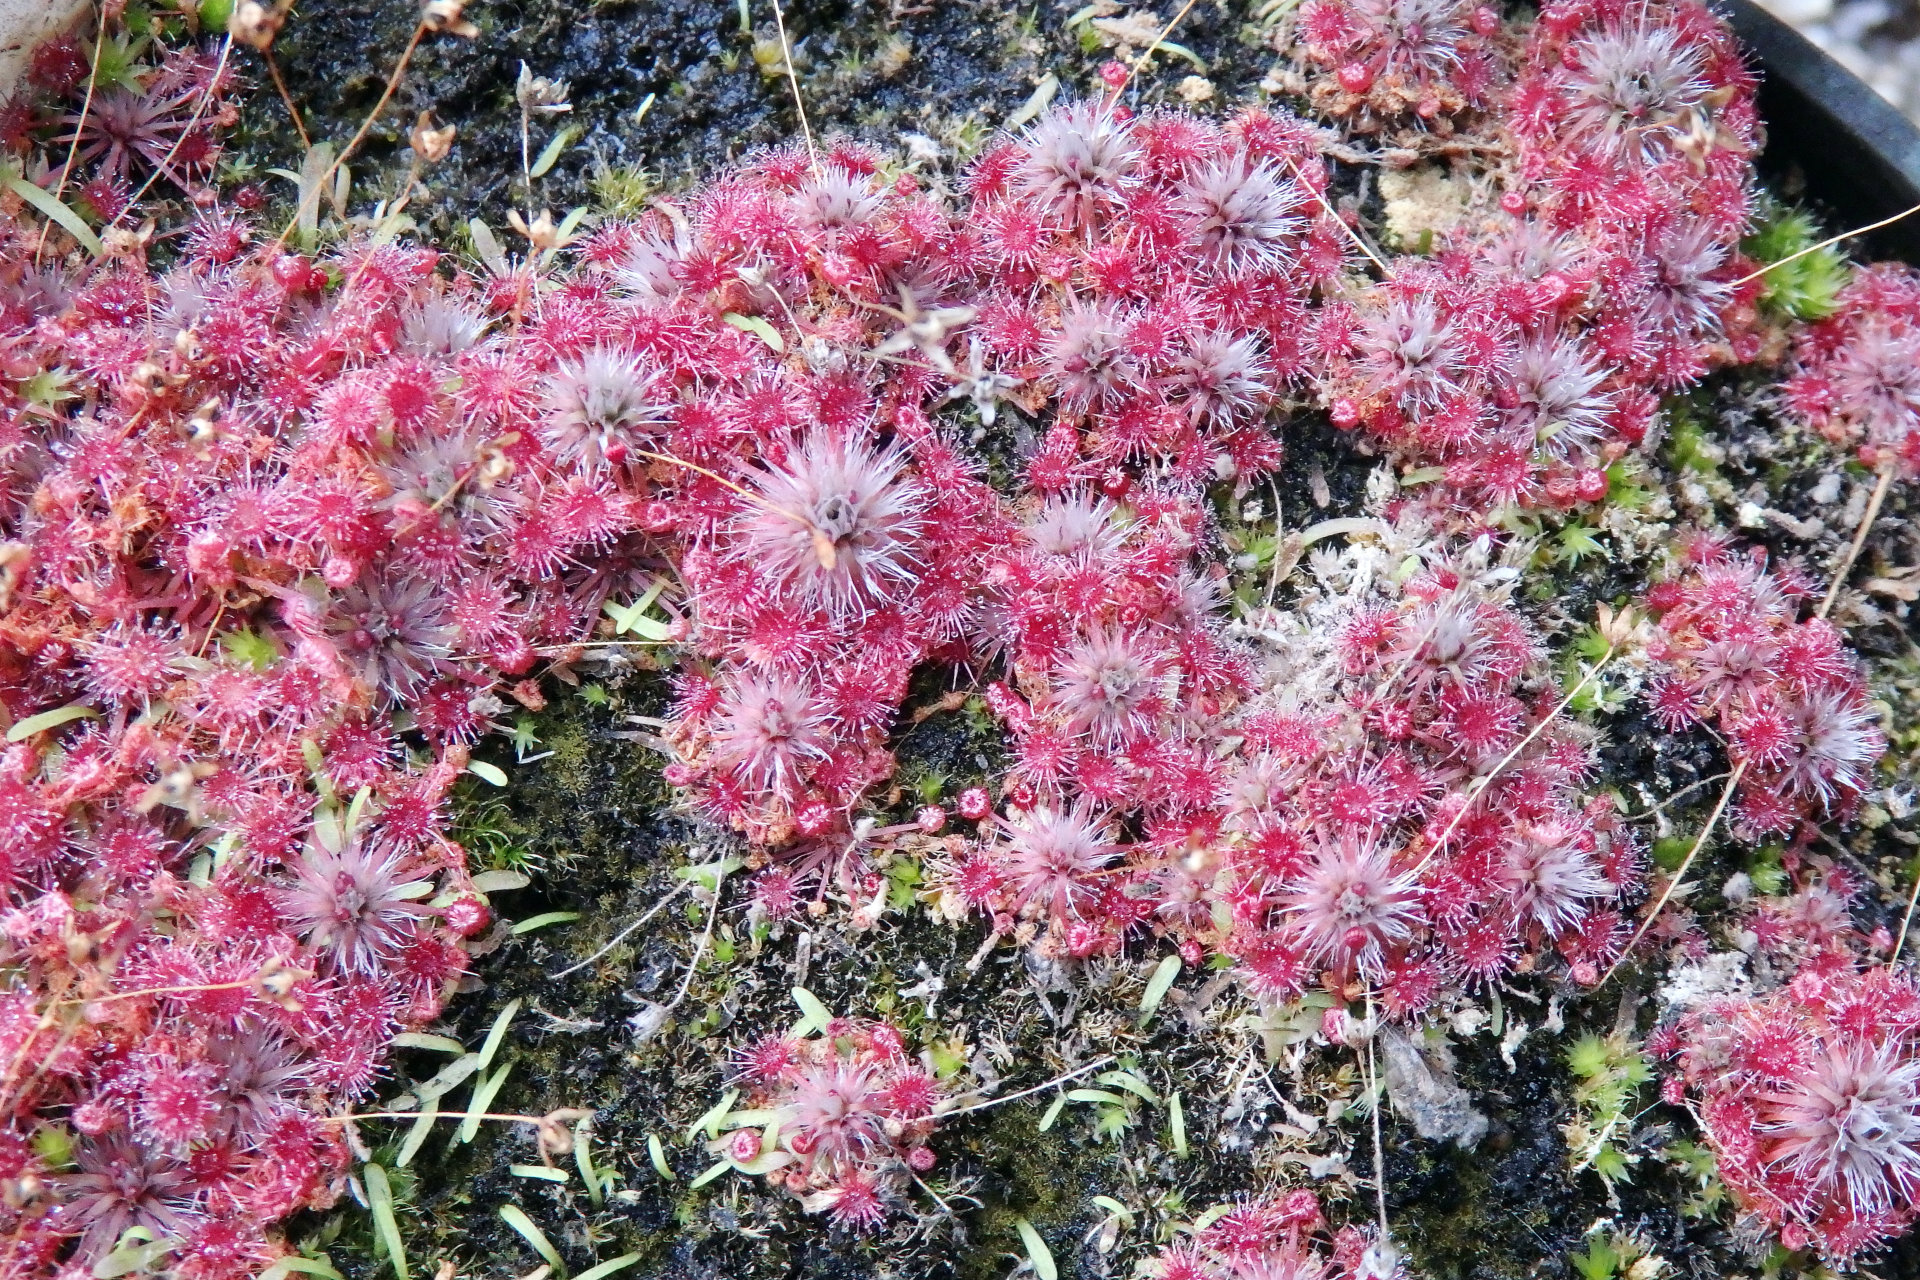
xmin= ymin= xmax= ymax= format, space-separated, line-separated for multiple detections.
xmin=941 ymin=512 xmax=1642 ymax=1017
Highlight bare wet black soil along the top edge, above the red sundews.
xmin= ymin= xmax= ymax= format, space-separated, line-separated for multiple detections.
xmin=246 ymin=0 xmax=1269 ymax=238
